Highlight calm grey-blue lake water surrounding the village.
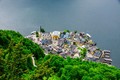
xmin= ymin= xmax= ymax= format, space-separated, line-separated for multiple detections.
xmin=0 ymin=0 xmax=120 ymax=67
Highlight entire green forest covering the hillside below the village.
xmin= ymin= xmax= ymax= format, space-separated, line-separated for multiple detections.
xmin=0 ymin=30 xmax=120 ymax=80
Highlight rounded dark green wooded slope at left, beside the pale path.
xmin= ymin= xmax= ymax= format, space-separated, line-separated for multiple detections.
xmin=0 ymin=30 xmax=44 ymax=80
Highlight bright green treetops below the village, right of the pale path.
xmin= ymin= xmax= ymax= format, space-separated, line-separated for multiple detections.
xmin=27 ymin=55 xmax=120 ymax=80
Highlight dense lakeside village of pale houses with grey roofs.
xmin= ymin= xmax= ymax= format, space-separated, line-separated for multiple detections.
xmin=26 ymin=30 xmax=112 ymax=64
